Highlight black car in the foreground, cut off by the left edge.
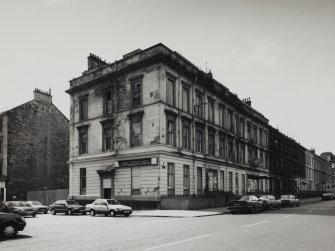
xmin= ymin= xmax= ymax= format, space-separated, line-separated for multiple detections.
xmin=0 ymin=212 xmax=26 ymax=239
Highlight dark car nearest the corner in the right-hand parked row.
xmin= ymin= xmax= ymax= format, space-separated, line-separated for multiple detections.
xmin=227 ymin=195 xmax=264 ymax=213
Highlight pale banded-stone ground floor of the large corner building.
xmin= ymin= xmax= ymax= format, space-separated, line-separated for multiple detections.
xmin=69 ymin=153 xmax=269 ymax=208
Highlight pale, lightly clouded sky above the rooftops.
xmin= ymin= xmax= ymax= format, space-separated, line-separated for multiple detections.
xmin=0 ymin=0 xmax=335 ymax=154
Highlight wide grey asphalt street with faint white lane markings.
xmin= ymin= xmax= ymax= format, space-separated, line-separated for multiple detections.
xmin=0 ymin=200 xmax=335 ymax=251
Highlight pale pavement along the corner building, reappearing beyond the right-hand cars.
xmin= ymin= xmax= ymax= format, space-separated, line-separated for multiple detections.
xmin=132 ymin=197 xmax=322 ymax=218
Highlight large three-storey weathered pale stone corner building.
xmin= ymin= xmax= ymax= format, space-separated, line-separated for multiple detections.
xmin=67 ymin=44 xmax=269 ymax=205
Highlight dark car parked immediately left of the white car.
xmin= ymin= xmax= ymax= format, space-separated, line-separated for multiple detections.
xmin=49 ymin=200 xmax=86 ymax=215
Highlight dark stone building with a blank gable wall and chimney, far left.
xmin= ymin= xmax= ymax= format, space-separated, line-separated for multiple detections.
xmin=0 ymin=89 xmax=69 ymax=200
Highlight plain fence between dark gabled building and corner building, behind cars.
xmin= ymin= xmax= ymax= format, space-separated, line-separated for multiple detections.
xmin=27 ymin=189 xmax=69 ymax=206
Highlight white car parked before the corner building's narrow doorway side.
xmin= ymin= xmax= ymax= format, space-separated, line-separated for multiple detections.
xmin=86 ymin=199 xmax=133 ymax=217
